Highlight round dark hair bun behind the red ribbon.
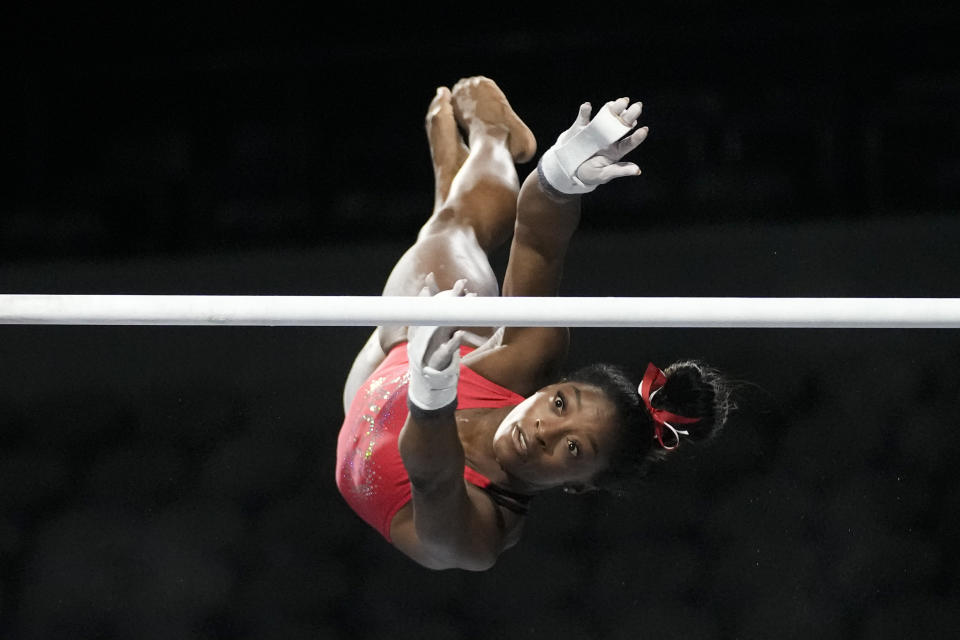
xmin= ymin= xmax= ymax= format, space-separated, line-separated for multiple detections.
xmin=651 ymin=360 xmax=734 ymax=442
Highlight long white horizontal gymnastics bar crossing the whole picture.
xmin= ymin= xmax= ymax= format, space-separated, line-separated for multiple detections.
xmin=0 ymin=294 xmax=960 ymax=329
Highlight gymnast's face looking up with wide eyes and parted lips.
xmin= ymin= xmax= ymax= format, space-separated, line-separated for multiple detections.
xmin=493 ymin=382 xmax=617 ymax=491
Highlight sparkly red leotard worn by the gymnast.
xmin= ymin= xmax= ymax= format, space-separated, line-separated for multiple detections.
xmin=336 ymin=342 xmax=528 ymax=540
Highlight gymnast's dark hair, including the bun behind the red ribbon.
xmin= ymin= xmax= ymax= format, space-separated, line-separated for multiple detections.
xmin=566 ymin=360 xmax=736 ymax=492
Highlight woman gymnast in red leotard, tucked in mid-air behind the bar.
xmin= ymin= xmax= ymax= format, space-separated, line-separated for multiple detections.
xmin=336 ymin=76 xmax=732 ymax=571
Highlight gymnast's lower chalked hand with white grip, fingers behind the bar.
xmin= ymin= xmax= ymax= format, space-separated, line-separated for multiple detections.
xmin=407 ymin=273 xmax=472 ymax=413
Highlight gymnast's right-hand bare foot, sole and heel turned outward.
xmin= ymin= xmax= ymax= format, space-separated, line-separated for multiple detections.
xmin=453 ymin=76 xmax=537 ymax=163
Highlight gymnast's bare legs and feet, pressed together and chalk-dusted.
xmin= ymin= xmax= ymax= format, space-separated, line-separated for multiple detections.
xmin=344 ymin=77 xmax=537 ymax=416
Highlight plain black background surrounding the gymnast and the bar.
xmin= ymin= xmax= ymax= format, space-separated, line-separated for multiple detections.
xmin=0 ymin=5 xmax=960 ymax=638
